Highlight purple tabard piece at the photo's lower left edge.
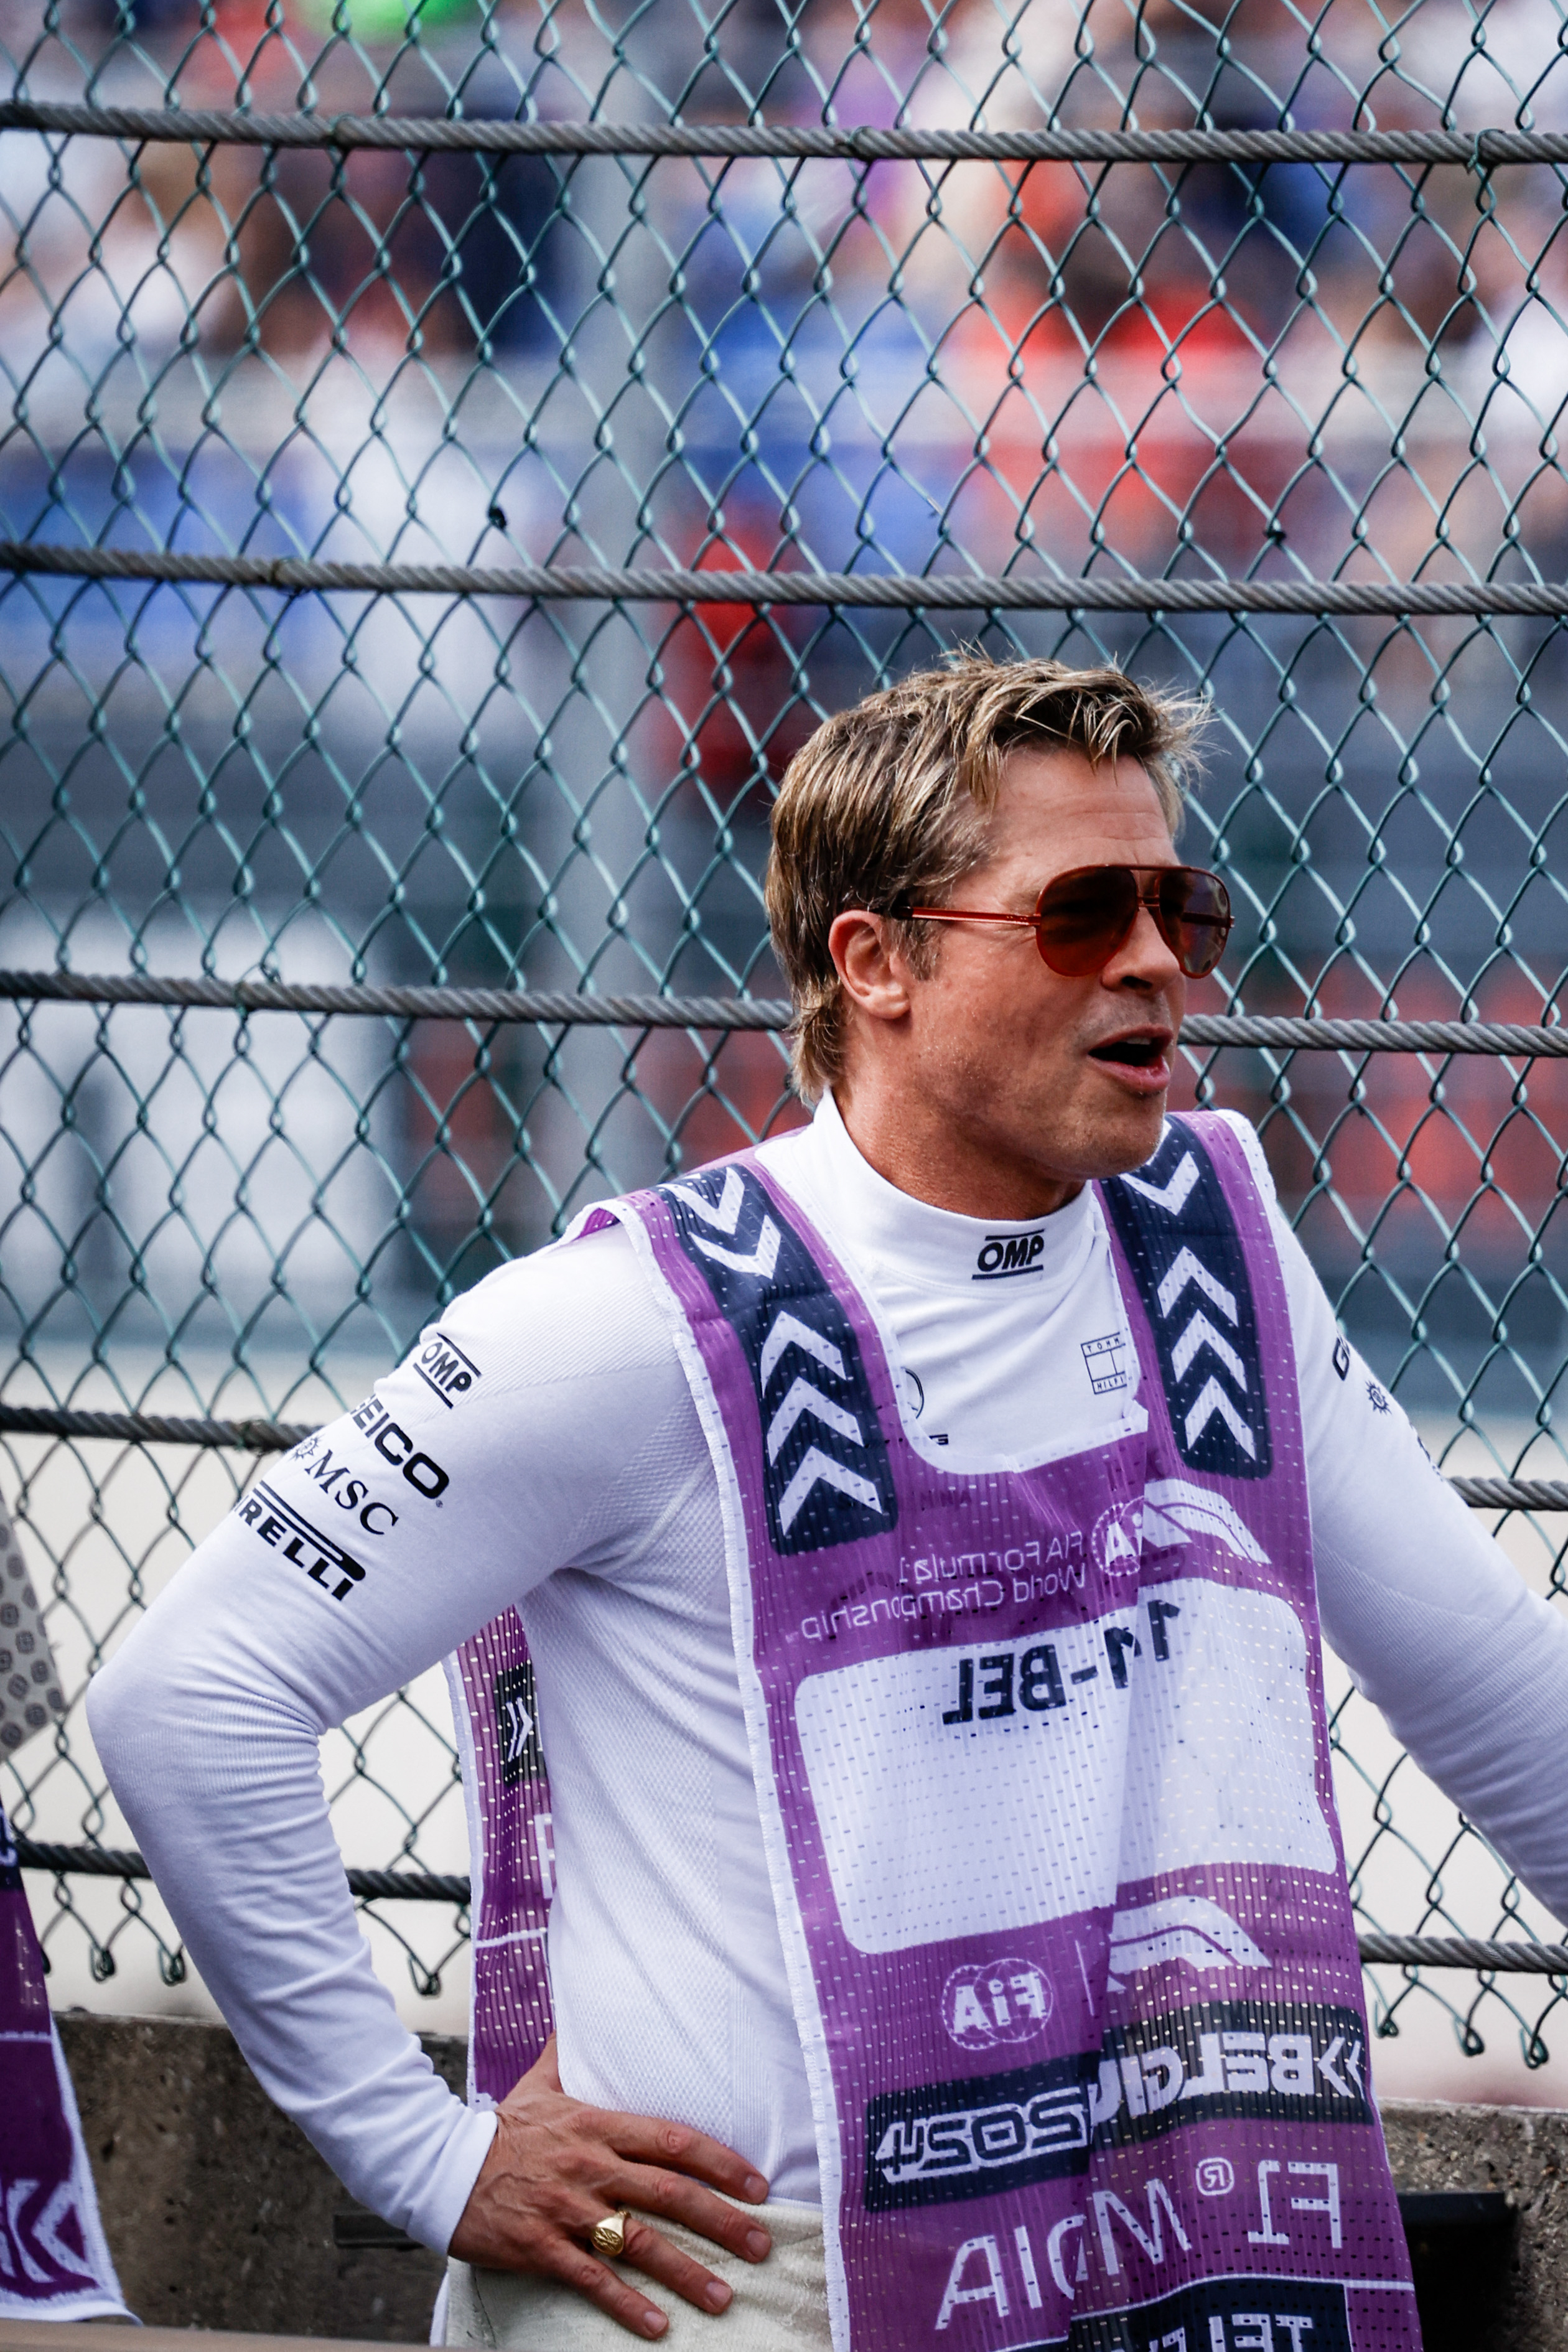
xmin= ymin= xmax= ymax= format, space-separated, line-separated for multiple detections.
xmin=0 ymin=1811 xmax=129 ymax=2319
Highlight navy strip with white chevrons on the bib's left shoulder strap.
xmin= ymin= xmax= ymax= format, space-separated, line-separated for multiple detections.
xmin=658 ymin=1167 xmax=898 ymax=1552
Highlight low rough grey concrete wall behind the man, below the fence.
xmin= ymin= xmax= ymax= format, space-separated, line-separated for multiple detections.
xmin=58 ymin=2014 xmax=1568 ymax=2352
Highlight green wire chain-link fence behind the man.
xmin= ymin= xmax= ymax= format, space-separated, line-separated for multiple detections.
xmin=0 ymin=0 xmax=1568 ymax=2098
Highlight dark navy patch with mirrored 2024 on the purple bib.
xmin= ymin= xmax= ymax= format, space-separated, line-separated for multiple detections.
xmin=865 ymin=2058 xmax=1096 ymax=2213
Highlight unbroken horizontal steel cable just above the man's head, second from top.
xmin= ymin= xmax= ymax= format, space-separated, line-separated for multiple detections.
xmin=0 ymin=539 xmax=1568 ymax=621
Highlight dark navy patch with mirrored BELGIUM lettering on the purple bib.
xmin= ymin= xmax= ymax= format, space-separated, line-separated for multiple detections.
xmin=1088 ymin=2002 xmax=1373 ymax=2147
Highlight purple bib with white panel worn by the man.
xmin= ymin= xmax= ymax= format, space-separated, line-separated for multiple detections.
xmin=459 ymin=1115 xmax=1420 ymax=2352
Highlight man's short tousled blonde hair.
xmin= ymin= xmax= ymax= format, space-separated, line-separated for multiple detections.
xmin=767 ymin=651 xmax=1208 ymax=1103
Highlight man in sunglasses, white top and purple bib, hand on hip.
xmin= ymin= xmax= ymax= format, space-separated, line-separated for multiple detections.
xmin=91 ymin=656 xmax=1568 ymax=2352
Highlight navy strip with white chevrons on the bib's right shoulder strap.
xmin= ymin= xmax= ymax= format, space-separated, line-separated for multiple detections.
xmin=1103 ymin=1119 xmax=1272 ymax=1477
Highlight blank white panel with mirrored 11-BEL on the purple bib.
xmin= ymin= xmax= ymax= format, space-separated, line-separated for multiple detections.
xmin=795 ymin=1576 xmax=1335 ymax=1952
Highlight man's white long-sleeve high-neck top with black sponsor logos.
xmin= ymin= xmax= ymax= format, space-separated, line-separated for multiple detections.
xmin=90 ymin=1101 xmax=1568 ymax=2249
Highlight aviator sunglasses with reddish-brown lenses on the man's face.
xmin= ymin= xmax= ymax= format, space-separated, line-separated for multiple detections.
xmin=895 ymin=866 xmax=1232 ymax=981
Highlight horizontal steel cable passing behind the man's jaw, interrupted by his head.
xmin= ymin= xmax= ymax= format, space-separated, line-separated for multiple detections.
xmin=0 ymin=971 xmax=1568 ymax=1061
